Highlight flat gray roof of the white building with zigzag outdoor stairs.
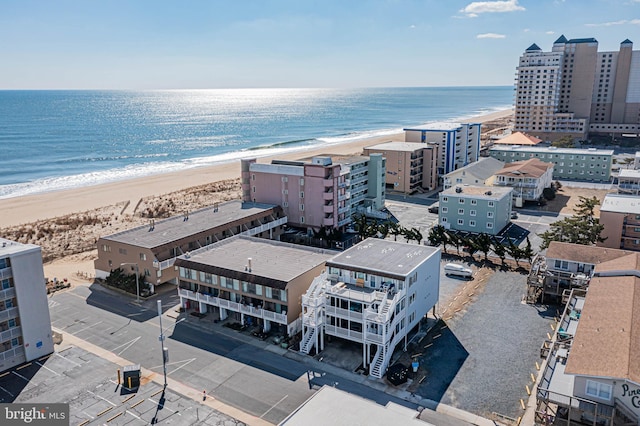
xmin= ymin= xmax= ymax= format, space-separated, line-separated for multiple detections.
xmin=327 ymin=238 xmax=440 ymax=280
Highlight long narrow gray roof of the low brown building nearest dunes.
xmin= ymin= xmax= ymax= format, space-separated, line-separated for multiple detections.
xmin=102 ymin=200 xmax=276 ymax=249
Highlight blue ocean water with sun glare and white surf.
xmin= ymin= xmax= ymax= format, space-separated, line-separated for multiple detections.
xmin=0 ymin=86 xmax=513 ymax=198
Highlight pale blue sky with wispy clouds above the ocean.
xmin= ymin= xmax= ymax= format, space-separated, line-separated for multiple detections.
xmin=0 ymin=0 xmax=640 ymax=89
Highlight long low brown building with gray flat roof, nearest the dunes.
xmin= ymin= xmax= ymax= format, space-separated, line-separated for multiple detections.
xmin=94 ymin=200 xmax=287 ymax=290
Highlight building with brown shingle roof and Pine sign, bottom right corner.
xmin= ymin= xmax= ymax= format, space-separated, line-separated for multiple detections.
xmin=535 ymin=253 xmax=640 ymax=425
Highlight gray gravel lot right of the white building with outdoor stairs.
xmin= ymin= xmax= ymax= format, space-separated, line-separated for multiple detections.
xmin=416 ymin=271 xmax=555 ymax=418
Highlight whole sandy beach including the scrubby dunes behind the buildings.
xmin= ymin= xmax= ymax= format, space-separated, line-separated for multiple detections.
xmin=0 ymin=109 xmax=513 ymax=279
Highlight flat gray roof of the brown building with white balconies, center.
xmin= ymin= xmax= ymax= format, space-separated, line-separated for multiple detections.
xmin=175 ymin=235 xmax=336 ymax=289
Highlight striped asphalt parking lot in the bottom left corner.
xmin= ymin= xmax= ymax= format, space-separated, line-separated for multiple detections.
xmin=0 ymin=343 xmax=238 ymax=426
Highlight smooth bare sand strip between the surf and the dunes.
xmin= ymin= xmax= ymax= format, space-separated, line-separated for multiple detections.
xmin=0 ymin=109 xmax=513 ymax=228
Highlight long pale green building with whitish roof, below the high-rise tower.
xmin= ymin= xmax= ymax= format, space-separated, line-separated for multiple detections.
xmin=489 ymin=145 xmax=613 ymax=182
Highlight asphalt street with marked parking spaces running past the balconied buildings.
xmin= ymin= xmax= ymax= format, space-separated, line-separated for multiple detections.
xmin=49 ymin=285 xmax=436 ymax=424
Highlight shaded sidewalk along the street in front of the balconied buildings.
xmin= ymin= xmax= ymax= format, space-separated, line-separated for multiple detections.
xmin=172 ymin=308 xmax=500 ymax=426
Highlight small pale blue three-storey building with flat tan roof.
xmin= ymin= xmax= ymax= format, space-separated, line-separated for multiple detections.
xmin=438 ymin=185 xmax=513 ymax=235
